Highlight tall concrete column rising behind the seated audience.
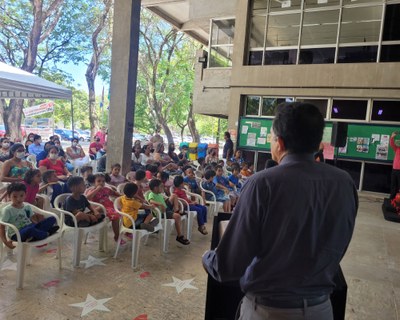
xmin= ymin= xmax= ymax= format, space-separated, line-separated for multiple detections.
xmin=107 ymin=0 xmax=141 ymax=174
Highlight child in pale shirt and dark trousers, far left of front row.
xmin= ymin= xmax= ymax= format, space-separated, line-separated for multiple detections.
xmin=0 ymin=182 xmax=59 ymax=249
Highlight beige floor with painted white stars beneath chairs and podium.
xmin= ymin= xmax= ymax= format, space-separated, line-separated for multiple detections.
xmin=0 ymin=196 xmax=400 ymax=320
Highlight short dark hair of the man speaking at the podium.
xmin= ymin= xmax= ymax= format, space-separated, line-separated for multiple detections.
xmin=272 ymin=102 xmax=325 ymax=153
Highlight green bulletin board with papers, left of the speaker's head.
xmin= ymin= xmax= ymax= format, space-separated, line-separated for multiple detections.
xmin=239 ymin=117 xmax=273 ymax=151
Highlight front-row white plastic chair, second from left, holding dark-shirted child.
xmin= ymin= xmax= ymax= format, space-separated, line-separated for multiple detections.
xmin=54 ymin=193 xmax=108 ymax=267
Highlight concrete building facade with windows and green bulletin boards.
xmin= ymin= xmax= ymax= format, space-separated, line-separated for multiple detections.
xmin=190 ymin=0 xmax=400 ymax=192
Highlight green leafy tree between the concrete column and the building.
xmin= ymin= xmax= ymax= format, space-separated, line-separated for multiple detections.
xmin=136 ymin=10 xmax=198 ymax=143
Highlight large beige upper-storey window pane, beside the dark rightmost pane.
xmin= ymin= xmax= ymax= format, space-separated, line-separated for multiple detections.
xmin=340 ymin=6 xmax=382 ymax=43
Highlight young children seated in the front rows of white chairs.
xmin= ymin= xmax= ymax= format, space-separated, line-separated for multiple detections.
xmin=1 ymin=146 xmax=251 ymax=246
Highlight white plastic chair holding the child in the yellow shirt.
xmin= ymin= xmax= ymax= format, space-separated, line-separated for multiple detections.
xmin=114 ymin=197 xmax=163 ymax=269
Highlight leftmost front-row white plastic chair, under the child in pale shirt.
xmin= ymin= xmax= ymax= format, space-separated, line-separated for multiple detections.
xmin=0 ymin=203 xmax=63 ymax=289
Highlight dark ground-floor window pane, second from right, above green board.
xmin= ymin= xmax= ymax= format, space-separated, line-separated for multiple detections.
xmin=331 ymin=99 xmax=368 ymax=120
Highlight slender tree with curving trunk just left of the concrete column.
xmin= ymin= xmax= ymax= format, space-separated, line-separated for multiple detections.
xmin=85 ymin=0 xmax=112 ymax=136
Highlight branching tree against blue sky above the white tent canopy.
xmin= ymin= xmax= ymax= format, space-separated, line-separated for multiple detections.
xmin=0 ymin=0 xmax=87 ymax=137
